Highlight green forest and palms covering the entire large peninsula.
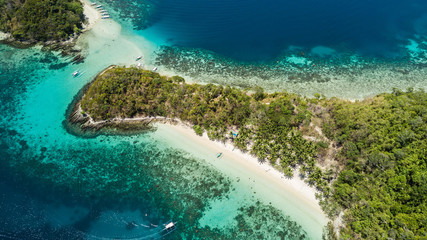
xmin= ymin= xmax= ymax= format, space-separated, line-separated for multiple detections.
xmin=81 ymin=68 xmax=427 ymax=239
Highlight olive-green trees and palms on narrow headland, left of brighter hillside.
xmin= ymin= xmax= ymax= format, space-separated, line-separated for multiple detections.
xmin=81 ymin=68 xmax=329 ymax=187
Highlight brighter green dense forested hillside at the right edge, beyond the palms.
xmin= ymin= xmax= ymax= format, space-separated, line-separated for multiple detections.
xmin=323 ymin=89 xmax=427 ymax=239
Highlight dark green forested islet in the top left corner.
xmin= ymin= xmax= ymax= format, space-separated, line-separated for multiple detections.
xmin=0 ymin=0 xmax=84 ymax=42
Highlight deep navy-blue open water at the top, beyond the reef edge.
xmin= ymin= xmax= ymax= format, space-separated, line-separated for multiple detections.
xmin=138 ymin=0 xmax=427 ymax=61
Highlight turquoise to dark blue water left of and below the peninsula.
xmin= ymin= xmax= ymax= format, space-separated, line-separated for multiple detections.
xmin=0 ymin=25 xmax=319 ymax=239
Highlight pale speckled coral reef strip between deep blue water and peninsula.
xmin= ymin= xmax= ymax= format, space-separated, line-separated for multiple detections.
xmin=156 ymin=43 xmax=427 ymax=99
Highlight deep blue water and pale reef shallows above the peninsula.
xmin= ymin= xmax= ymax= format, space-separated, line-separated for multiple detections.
xmin=97 ymin=0 xmax=427 ymax=99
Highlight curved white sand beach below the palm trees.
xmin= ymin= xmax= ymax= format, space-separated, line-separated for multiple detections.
xmin=153 ymin=123 xmax=328 ymax=239
